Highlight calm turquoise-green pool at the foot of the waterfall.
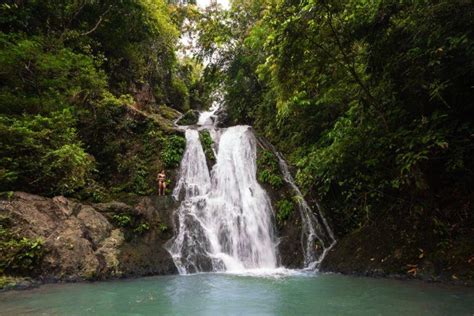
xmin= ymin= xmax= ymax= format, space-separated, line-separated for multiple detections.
xmin=0 ymin=274 xmax=474 ymax=316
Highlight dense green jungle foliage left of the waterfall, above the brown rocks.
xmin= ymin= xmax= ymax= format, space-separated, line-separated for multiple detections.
xmin=0 ymin=0 xmax=203 ymax=200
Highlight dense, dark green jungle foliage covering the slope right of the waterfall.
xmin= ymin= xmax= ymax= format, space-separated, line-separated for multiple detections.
xmin=193 ymin=0 xmax=474 ymax=276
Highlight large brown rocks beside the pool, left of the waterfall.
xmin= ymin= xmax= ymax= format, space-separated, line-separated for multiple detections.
xmin=0 ymin=192 xmax=177 ymax=282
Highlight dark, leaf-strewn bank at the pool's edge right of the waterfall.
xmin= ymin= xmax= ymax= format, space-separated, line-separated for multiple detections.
xmin=320 ymin=218 xmax=474 ymax=286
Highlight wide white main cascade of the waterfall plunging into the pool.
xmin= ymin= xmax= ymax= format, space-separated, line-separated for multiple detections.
xmin=168 ymin=119 xmax=277 ymax=274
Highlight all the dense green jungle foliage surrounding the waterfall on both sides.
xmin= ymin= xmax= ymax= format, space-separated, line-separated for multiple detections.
xmin=0 ymin=0 xmax=474 ymax=278
